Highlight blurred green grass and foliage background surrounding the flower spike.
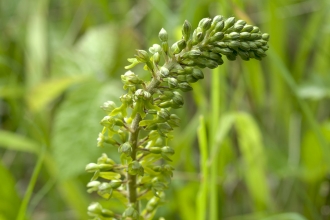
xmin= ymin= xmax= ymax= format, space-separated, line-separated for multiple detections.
xmin=0 ymin=0 xmax=330 ymax=220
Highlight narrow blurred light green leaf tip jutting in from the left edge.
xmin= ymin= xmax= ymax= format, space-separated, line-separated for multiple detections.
xmin=0 ymin=130 xmax=39 ymax=153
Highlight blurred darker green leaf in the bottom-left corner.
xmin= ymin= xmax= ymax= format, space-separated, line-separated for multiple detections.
xmin=0 ymin=162 xmax=21 ymax=220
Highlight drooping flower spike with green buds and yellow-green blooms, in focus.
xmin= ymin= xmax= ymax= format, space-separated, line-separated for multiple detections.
xmin=86 ymin=16 xmax=269 ymax=220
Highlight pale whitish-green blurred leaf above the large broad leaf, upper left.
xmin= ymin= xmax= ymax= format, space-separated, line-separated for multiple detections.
xmin=51 ymin=23 xmax=118 ymax=78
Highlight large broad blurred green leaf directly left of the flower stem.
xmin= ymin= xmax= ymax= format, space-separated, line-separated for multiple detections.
xmin=51 ymin=78 xmax=122 ymax=178
